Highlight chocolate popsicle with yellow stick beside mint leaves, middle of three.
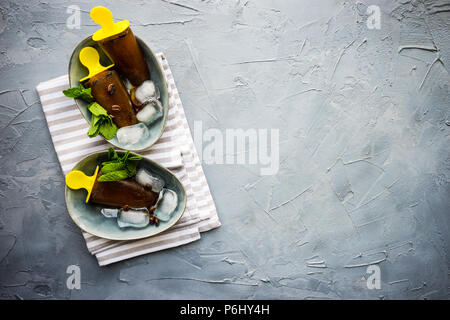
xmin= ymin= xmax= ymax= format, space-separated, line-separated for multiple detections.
xmin=79 ymin=47 xmax=137 ymax=128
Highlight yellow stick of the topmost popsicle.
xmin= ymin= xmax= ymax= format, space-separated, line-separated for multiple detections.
xmin=91 ymin=6 xmax=130 ymax=41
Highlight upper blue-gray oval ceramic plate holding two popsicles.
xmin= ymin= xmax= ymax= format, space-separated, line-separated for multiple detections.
xmin=69 ymin=37 xmax=169 ymax=151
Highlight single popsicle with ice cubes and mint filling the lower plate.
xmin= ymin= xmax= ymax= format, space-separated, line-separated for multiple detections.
xmin=66 ymin=148 xmax=178 ymax=228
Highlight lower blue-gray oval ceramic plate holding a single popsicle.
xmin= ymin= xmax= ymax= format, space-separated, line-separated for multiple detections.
xmin=65 ymin=151 xmax=186 ymax=240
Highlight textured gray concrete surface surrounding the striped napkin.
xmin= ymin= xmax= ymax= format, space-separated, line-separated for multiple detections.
xmin=0 ymin=0 xmax=450 ymax=299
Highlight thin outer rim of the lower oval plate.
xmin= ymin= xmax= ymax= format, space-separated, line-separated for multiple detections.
xmin=64 ymin=150 xmax=187 ymax=241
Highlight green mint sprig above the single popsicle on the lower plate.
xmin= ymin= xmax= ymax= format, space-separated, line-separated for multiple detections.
xmin=98 ymin=148 xmax=142 ymax=182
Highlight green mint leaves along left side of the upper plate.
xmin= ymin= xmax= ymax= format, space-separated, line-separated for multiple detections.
xmin=63 ymin=84 xmax=117 ymax=140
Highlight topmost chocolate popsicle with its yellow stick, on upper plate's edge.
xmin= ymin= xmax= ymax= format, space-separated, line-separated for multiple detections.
xmin=91 ymin=6 xmax=150 ymax=87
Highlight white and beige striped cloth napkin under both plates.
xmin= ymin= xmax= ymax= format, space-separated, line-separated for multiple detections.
xmin=36 ymin=53 xmax=220 ymax=266
